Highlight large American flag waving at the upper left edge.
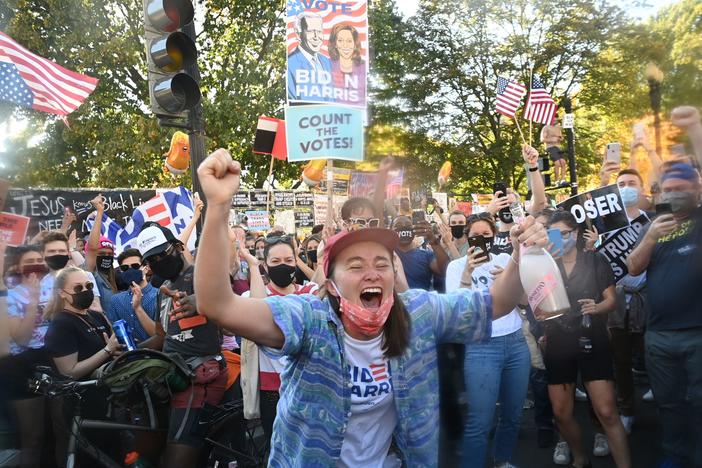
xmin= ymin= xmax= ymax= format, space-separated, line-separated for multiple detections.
xmin=0 ymin=32 xmax=98 ymax=116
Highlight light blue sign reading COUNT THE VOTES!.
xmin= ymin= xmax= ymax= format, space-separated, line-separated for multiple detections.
xmin=285 ymin=105 xmax=363 ymax=162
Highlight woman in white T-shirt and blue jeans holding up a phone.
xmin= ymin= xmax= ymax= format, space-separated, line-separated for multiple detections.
xmin=446 ymin=213 xmax=531 ymax=468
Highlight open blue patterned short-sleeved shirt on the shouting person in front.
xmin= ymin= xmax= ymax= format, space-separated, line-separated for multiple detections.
xmin=263 ymin=289 xmax=492 ymax=468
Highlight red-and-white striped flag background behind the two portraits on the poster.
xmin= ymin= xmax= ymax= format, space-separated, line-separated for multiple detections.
xmin=286 ymin=0 xmax=368 ymax=60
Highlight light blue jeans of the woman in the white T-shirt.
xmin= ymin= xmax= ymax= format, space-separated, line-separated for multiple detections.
xmin=461 ymin=330 xmax=531 ymax=468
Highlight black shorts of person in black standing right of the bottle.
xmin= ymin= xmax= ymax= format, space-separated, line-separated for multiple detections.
xmin=544 ymin=329 xmax=614 ymax=385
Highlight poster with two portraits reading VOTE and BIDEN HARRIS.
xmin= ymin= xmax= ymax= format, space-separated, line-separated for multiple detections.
xmin=286 ymin=0 xmax=368 ymax=106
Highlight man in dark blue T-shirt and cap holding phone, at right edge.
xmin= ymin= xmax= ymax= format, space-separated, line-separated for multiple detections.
xmin=627 ymin=163 xmax=702 ymax=466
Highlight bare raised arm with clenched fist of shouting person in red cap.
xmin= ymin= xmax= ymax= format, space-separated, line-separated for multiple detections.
xmin=195 ymin=149 xmax=284 ymax=348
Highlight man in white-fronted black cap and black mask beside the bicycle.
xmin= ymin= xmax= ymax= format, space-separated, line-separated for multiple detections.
xmin=137 ymin=222 xmax=227 ymax=467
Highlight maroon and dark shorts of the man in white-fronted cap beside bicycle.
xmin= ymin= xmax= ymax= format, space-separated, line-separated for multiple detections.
xmin=168 ymin=359 xmax=228 ymax=447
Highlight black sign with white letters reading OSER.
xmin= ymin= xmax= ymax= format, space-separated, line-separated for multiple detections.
xmin=558 ymin=184 xmax=629 ymax=234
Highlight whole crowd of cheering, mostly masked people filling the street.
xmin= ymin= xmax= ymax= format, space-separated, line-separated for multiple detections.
xmin=0 ymin=107 xmax=702 ymax=468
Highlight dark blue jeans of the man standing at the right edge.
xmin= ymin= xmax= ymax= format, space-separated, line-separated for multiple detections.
xmin=645 ymin=328 xmax=702 ymax=466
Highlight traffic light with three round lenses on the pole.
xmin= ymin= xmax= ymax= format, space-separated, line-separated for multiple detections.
xmin=144 ymin=0 xmax=201 ymax=119
